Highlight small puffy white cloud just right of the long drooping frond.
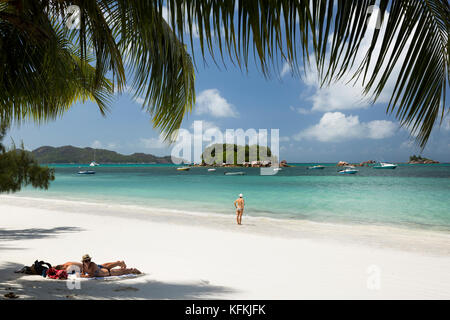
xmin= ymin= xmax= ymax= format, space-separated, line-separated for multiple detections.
xmin=196 ymin=89 xmax=238 ymax=118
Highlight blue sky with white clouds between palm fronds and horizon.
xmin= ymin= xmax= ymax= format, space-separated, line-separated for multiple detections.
xmin=5 ymin=5 xmax=450 ymax=163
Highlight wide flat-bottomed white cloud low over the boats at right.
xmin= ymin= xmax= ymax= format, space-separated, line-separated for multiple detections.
xmin=294 ymin=112 xmax=397 ymax=142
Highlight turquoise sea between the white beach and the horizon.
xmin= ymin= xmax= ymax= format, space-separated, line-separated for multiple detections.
xmin=12 ymin=164 xmax=450 ymax=231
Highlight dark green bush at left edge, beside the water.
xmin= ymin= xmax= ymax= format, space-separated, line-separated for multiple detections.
xmin=0 ymin=124 xmax=55 ymax=193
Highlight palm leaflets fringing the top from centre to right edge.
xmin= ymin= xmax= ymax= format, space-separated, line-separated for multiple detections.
xmin=167 ymin=0 xmax=450 ymax=147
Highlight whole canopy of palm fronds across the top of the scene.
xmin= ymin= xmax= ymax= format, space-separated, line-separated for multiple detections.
xmin=0 ymin=0 xmax=450 ymax=147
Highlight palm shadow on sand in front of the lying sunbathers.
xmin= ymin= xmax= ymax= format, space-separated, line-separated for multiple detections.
xmin=0 ymin=262 xmax=235 ymax=299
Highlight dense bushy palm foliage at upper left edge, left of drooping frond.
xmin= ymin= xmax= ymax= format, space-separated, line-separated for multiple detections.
xmin=0 ymin=4 xmax=113 ymax=123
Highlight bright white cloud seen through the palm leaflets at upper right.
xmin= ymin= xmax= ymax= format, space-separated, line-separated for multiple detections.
xmin=303 ymin=6 xmax=405 ymax=112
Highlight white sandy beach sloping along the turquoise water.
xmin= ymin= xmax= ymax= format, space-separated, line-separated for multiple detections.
xmin=0 ymin=196 xmax=450 ymax=299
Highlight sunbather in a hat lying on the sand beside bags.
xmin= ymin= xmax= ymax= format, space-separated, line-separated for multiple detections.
xmin=55 ymin=254 xmax=141 ymax=278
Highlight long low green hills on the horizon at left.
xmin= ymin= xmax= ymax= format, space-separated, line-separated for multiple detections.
xmin=31 ymin=146 xmax=177 ymax=164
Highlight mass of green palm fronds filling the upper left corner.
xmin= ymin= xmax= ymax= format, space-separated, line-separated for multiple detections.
xmin=0 ymin=0 xmax=195 ymax=139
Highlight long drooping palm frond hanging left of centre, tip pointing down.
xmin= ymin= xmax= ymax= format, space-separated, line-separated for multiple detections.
xmin=111 ymin=1 xmax=195 ymax=140
